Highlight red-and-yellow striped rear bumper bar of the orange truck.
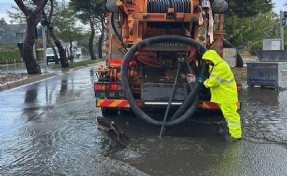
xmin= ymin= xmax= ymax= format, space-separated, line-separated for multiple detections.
xmin=96 ymin=99 xmax=241 ymax=110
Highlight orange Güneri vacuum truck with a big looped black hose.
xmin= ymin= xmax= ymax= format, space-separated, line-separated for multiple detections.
xmin=94 ymin=0 xmax=240 ymax=126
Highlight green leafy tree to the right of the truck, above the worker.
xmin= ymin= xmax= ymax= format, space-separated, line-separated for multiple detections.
xmin=224 ymin=0 xmax=277 ymax=48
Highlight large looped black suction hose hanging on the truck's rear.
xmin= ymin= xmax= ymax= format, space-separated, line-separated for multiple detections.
xmin=121 ymin=35 xmax=206 ymax=127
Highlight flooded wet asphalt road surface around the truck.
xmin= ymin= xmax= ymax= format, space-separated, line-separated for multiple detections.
xmin=0 ymin=64 xmax=287 ymax=176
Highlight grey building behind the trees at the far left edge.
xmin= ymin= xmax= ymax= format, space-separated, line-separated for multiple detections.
xmin=0 ymin=24 xmax=27 ymax=43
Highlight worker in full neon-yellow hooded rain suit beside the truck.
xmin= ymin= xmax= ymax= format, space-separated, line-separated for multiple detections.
xmin=202 ymin=50 xmax=242 ymax=141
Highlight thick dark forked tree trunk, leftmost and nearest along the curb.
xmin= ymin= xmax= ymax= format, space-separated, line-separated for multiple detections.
xmin=14 ymin=0 xmax=48 ymax=74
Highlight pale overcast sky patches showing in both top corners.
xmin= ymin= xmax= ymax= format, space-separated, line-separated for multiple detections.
xmin=0 ymin=0 xmax=287 ymax=23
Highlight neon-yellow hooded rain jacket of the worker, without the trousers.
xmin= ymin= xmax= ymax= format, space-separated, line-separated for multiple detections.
xmin=202 ymin=50 xmax=238 ymax=104
